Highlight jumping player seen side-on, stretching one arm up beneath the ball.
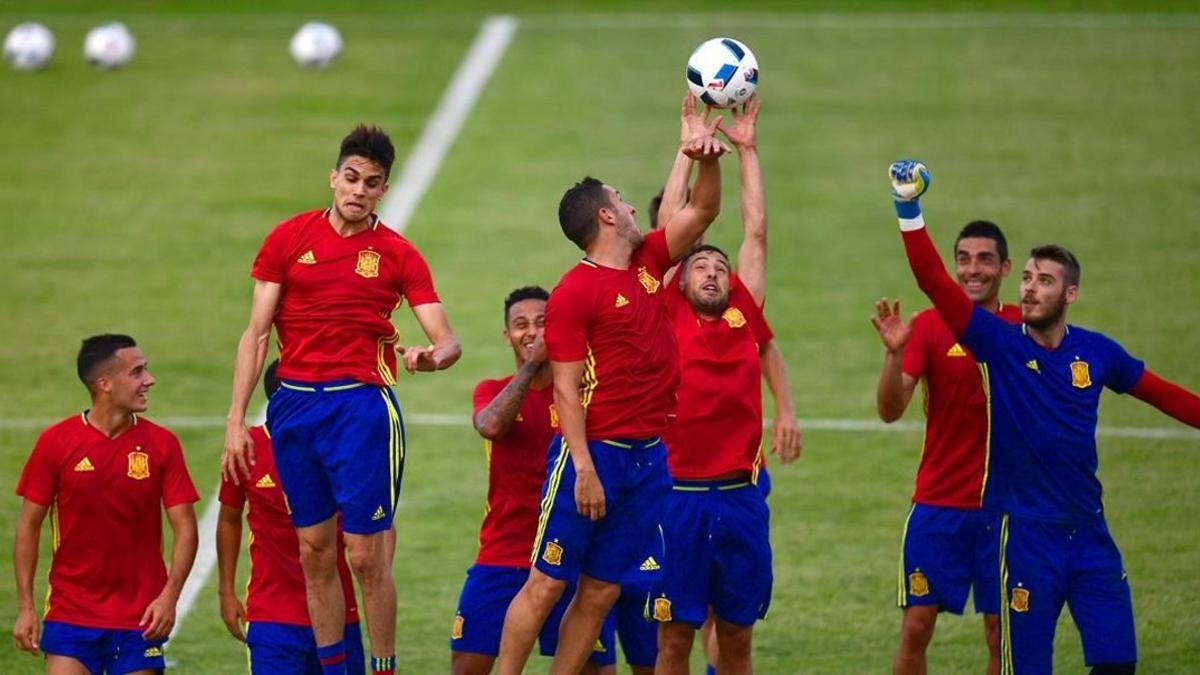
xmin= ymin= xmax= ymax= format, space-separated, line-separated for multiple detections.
xmin=500 ymin=94 xmax=727 ymax=675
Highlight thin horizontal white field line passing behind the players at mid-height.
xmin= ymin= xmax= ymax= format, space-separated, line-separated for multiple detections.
xmin=0 ymin=412 xmax=1200 ymax=441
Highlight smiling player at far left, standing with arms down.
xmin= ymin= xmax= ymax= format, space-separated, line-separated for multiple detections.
xmin=12 ymin=334 xmax=199 ymax=675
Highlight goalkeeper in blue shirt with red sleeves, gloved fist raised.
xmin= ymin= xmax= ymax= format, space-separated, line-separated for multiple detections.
xmin=889 ymin=161 xmax=1200 ymax=675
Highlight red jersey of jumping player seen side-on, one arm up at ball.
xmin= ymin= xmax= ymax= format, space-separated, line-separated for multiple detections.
xmin=545 ymin=229 xmax=679 ymax=440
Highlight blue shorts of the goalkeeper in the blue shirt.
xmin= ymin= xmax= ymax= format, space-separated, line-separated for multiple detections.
xmin=998 ymin=514 xmax=1138 ymax=674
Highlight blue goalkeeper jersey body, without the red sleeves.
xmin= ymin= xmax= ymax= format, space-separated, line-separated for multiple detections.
xmin=962 ymin=306 xmax=1145 ymax=522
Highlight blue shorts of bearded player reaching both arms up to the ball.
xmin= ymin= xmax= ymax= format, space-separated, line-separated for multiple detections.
xmin=652 ymin=479 xmax=773 ymax=628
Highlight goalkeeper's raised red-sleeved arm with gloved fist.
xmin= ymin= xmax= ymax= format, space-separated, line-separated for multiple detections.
xmin=888 ymin=160 xmax=974 ymax=338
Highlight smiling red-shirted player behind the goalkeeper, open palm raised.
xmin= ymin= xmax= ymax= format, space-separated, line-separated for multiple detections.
xmin=871 ymin=220 xmax=1021 ymax=675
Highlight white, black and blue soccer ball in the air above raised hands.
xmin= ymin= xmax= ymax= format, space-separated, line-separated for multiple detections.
xmin=688 ymin=37 xmax=758 ymax=108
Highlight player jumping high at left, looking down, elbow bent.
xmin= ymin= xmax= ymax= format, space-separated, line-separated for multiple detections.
xmin=221 ymin=125 xmax=462 ymax=674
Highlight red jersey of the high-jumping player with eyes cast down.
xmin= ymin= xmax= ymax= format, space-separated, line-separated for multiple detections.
xmin=251 ymin=210 xmax=438 ymax=386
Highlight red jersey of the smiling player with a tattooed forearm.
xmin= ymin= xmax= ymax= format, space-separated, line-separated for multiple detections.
xmin=474 ymin=375 xmax=558 ymax=567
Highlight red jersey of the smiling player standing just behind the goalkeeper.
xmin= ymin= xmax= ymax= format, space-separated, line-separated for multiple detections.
xmin=900 ymin=304 xmax=1021 ymax=509
